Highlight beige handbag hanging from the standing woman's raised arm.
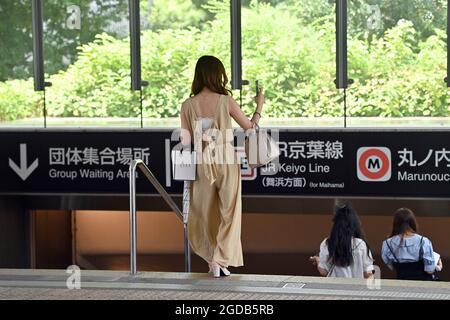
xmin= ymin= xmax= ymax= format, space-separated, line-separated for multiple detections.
xmin=245 ymin=124 xmax=280 ymax=169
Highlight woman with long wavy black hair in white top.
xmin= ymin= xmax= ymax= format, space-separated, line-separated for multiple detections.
xmin=310 ymin=205 xmax=374 ymax=278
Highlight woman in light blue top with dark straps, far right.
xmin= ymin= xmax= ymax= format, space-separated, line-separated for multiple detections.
xmin=381 ymin=208 xmax=442 ymax=280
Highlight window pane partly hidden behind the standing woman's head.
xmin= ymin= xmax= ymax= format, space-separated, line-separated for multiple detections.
xmin=141 ymin=0 xmax=227 ymax=127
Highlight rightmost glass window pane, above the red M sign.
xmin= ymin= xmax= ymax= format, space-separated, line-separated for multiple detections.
xmin=348 ymin=0 xmax=450 ymax=126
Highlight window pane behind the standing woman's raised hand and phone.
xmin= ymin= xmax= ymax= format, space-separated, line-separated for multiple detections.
xmin=242 ymin=0 xmax=344 ymax=127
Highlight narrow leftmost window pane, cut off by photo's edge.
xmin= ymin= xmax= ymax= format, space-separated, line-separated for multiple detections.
xmin=0 ymin=0 xmax=44 ymax=126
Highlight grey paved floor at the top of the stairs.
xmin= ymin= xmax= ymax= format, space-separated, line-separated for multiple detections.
xmin=0 ymin=269 xmax=450 ymax=300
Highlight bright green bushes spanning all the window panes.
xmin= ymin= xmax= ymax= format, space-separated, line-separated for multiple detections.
xmin=0 ymin=0 xmax=450 ymax=120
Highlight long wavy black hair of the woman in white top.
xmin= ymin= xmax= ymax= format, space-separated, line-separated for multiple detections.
xmin=327 ymin=204 xmax=370 ymax=267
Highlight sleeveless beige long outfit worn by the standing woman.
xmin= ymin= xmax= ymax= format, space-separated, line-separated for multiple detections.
xmin=187 ymin=95 xmax=243 ymax=267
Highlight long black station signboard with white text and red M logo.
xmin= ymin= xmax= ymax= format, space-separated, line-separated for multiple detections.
xmin=0 ymin=129 xmax=450 ymax=198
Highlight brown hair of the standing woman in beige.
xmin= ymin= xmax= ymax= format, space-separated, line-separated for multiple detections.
xmin=191 ymin=56 xmax=231 ymax=97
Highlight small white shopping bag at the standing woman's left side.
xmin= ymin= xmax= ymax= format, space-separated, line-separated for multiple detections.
xmin=171 ymin=150 xmax=197 ymax=181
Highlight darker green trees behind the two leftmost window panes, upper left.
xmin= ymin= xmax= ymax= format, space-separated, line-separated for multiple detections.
xmin=0 ymin=0 xmax=128 ymax=81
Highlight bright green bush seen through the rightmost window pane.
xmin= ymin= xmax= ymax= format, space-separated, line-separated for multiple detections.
xmin=349 ymin=22 xmax=450 ymax=117
